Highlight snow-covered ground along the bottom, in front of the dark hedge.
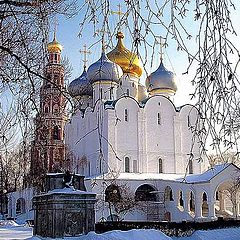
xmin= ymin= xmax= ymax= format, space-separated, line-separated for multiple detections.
xmin=0 ymin=221 xmax=240 ymax=240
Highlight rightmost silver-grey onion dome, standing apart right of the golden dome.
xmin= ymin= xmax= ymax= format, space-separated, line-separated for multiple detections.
xmin=146 ymin=61 xmax=177 ymax=95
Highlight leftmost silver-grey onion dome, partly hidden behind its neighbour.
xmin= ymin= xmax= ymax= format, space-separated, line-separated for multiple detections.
xmin=68 ymin=67 xmax=93 ymax=98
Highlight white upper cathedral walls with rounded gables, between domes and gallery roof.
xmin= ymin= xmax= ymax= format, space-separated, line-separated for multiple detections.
xmin=65 ymin=95 xmax=204 ymax=176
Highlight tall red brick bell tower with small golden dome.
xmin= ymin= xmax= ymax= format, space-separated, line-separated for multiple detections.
xmin=31 ymin=34 xmax=68 ymax=187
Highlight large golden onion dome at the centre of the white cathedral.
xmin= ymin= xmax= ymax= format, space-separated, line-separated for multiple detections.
xmin=107 ymin=32 xmax=143 ymax=78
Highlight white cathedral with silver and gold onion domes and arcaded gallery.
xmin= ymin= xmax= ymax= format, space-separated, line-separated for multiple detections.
xmin=5 ymin=32 xmax=240 ymax=222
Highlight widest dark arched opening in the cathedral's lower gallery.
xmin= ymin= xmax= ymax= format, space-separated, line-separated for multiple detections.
xmin=135 ymin=184 xmax=158 ymax=202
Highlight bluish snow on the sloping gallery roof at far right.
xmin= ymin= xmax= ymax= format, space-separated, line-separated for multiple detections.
xmin=177 ymin=163 xmax=231 ymax=183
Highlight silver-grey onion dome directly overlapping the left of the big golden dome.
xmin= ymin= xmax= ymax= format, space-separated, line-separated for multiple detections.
xmin=87 ymin=51 xmax=123 ymax=83
